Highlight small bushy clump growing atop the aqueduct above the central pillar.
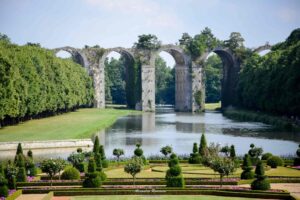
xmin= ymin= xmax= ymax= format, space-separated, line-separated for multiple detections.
xmin=134 ymin=34 xmax=161 ymax=50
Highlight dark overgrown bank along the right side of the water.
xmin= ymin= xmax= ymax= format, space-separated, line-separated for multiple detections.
xmin=223 ymin=108 xmax=300 ymax=131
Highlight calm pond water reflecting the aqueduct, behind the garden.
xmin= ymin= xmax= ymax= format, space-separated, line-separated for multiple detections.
xmin=98 ymin=109 xmax=300 ymax=157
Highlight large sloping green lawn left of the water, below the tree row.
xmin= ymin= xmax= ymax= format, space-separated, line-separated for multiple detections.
xmin=0 ymin=108 xmax=139 ymax=142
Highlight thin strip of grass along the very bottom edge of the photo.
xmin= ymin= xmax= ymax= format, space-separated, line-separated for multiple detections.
xmin=71 ymin=195 xmax=260 ymax=200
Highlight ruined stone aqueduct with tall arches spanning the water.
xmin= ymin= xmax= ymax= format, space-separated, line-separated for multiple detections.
xmin=54 ymin=44 xmax=271 ymax=112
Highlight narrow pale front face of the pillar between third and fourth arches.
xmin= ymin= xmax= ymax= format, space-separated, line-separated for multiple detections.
xmin=192 ymin=63 xmax=205 ymax=112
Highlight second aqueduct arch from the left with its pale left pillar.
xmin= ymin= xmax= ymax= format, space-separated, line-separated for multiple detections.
xmin=94 ymin=47 xmax=134 ymax=108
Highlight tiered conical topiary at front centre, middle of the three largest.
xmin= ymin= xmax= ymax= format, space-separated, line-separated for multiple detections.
xmin=165 ymin=153 xmax=185 ymax=188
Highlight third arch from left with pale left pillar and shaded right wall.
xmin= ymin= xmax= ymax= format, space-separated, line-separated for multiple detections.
xmin=142 ymin=44 xmax=192 ymax=111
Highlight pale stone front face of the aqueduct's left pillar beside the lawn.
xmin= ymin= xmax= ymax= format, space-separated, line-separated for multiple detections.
xmin=93 ymin=65 xmax=105 ymax=108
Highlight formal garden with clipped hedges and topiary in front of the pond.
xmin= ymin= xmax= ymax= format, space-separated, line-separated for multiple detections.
xmin=0 ymin=134 xmax=300 ymax=199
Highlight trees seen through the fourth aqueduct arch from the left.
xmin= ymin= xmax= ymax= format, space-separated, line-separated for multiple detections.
xmin=204 ymin=55 xmax=223 ymax=103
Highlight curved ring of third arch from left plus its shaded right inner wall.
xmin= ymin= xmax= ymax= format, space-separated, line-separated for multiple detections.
xmin=151 ymin=45 xmax=192 ymax=111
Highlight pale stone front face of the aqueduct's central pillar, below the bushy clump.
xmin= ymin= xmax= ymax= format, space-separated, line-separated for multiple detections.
xmin=142 ymin=64 xmax=155 ymax=112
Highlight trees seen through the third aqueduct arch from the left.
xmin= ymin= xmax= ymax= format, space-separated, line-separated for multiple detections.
xmin=155 ymin=56 xmax=175 ymax=105
